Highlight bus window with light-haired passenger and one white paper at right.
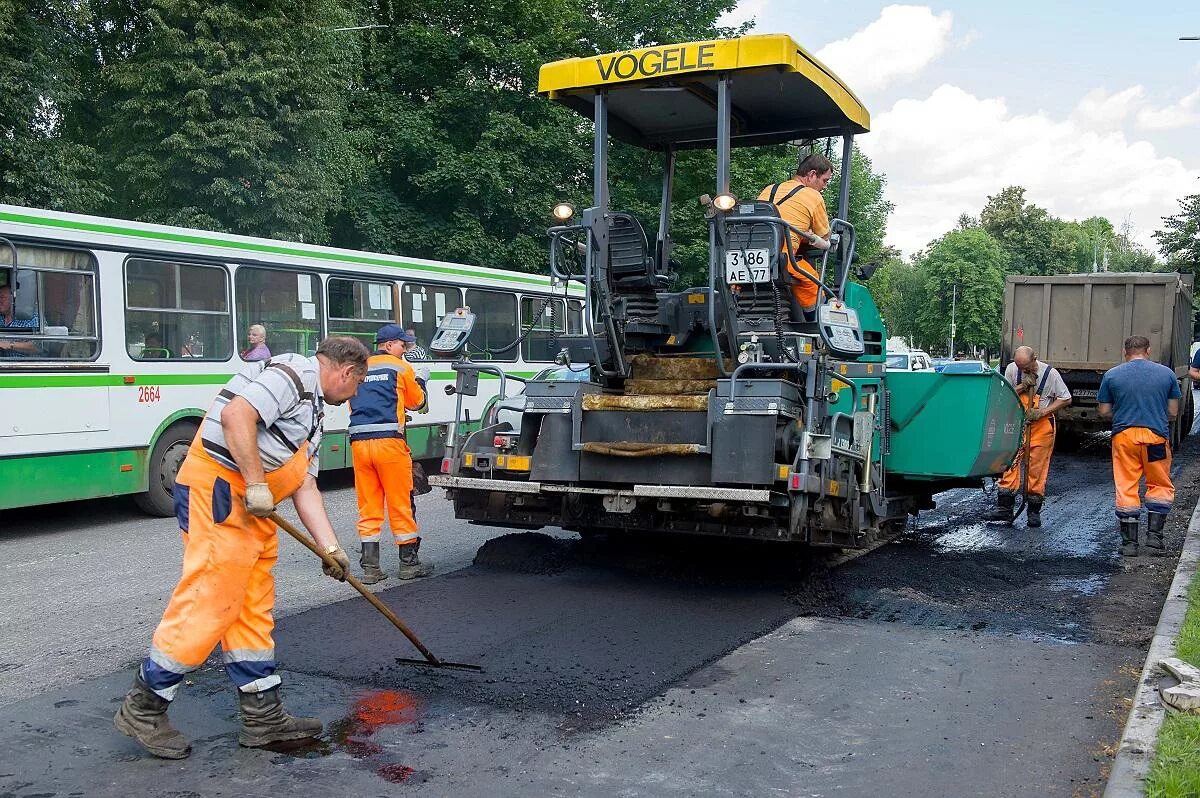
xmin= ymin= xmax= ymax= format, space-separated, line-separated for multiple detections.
xmin=234 ymin=266 xmax=322 ymax=356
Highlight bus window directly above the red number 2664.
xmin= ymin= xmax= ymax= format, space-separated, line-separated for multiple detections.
xmin=125 ymin=258 xmax=233 ymax=360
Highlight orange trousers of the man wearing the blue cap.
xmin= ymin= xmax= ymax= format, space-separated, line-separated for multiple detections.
xmin=350 ymin=438 xmax=416 ymax=546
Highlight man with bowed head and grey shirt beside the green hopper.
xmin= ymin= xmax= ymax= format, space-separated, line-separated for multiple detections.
xmin=985 ymin=347 xmax=1070 ymax=527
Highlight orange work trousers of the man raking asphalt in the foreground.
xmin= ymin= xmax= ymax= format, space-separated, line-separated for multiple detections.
xmin=142 ymin=436 xmax=308 ymax=701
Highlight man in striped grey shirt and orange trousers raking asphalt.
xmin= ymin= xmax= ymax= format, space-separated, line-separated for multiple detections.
xmin=113 ymin=337 xmax=368 ymax=760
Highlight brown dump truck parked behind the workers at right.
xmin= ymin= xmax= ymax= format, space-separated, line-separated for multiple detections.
xmin=1001 ymin=271 xmax=1194 ymax=449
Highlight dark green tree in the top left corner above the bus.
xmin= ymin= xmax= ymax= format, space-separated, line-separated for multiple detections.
xmin=0 ymin=0 xmax=104 ymax=211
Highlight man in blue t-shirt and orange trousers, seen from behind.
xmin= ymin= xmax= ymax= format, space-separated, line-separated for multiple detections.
xmin=1096 ymin=335 xmax=1181 ymax=557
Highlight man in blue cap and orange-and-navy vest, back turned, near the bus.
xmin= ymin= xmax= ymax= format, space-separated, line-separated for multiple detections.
xmin=349 ymin=324 xmax=433 ymax=584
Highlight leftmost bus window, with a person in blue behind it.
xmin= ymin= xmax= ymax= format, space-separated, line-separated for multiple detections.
xmin=0 ymin=245 xmax=100 ymax=360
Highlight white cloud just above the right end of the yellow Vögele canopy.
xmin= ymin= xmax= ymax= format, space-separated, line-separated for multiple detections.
xmin=816 ymin=4 xmax=954 ymax=94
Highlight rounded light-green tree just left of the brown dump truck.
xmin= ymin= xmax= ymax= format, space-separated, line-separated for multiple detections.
xmin=917 ymin=228 xmax=1006 ymax=350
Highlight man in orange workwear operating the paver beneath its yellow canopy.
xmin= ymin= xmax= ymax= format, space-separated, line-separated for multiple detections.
xmin=758 ymin=152 xmax=833 ymax=322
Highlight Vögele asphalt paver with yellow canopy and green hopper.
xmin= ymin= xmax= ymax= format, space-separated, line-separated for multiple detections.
xmin=431 ymin=35 xmax=1024 ymax=548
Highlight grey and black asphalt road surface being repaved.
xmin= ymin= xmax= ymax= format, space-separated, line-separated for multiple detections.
xmin=0 ymin=417 xmax=1200 ymax=798
